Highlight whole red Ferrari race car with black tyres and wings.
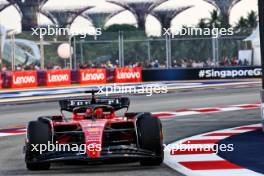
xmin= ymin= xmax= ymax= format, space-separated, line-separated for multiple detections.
xmin=24 ymin=91 xmax=164 ymax=170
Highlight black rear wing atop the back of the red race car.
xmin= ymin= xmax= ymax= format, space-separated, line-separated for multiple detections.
xmin=59 ymin=97 xmax=130 ymax=112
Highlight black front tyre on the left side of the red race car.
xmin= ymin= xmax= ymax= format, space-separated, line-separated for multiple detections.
xmin=25 ymin=121 xmax=51 ymax=170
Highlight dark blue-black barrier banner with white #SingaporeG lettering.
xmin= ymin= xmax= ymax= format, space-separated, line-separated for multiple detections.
xmin=142 ymin=66 xmax=262 ymax=81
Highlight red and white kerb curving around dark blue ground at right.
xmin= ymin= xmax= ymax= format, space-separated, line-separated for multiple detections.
xmin=164 ymin=124 xmax=263 ymax=176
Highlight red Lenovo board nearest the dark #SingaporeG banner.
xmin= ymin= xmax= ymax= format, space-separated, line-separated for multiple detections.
xmin=115 ymin=67 xmax=142 ymax=83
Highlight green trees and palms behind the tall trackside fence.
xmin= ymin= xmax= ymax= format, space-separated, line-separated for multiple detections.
xmin=29 ymin=11 xmax=257 ymax=64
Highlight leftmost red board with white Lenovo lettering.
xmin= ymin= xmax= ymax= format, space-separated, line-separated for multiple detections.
xmin=11 ymin=71 xmax=38 ymax=88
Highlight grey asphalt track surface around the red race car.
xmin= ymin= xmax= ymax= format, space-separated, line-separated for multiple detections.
xmin=0 ymin=87 xmax=260 ymax=176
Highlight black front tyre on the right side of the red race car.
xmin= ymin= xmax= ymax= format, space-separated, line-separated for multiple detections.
xmin=137 ymin=113 xmax=164 ymax=166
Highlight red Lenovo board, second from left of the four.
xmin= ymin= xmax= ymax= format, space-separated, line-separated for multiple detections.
xmin=46 ymin=70 xmax=71 ymax=86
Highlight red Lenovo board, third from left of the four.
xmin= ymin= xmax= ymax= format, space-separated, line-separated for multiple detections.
xmin=79 ymin=69 xmax=106 ymax=84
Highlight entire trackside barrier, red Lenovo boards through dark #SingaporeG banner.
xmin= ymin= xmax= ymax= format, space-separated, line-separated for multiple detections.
xmin=0 ymin=66 xmax=262 ymax=88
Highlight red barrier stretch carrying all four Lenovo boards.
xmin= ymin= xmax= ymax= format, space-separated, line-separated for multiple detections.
xmin=0 ymin=68 xmax=142 ymax=88
